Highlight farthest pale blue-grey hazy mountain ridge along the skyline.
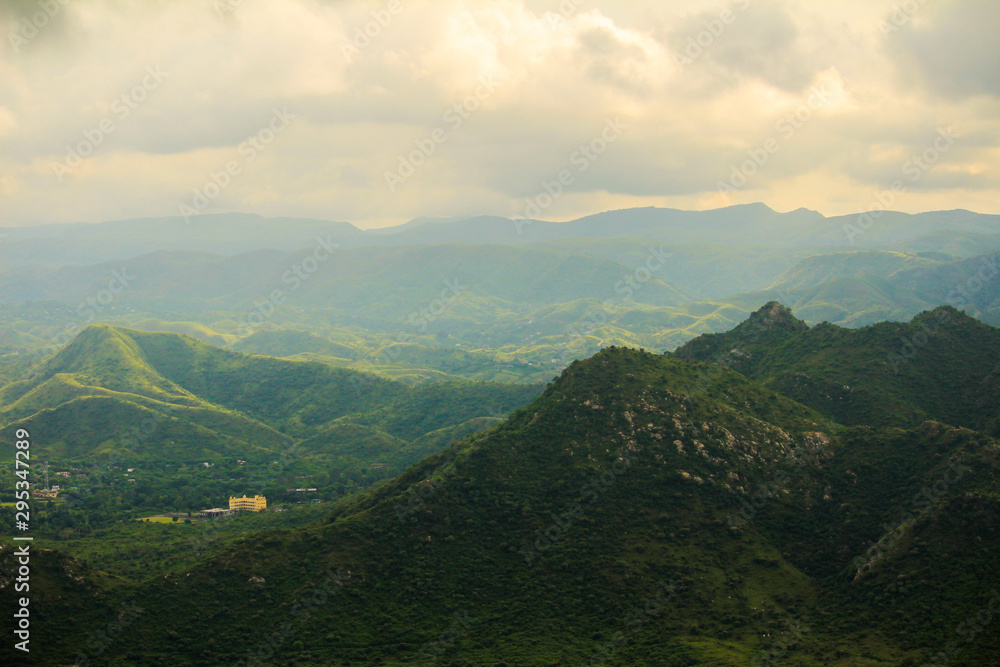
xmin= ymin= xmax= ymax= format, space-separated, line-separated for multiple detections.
xmin=0 ymin=203 xmax=1000 ymax=266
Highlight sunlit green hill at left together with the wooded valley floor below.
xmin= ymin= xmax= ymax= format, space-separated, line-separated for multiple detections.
xmin=0 ymin=325 xmax=541 ymax=533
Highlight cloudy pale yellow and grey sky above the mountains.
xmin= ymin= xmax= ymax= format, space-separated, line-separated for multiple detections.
xmin=0 ymin=0 xmax=1000 ymax=228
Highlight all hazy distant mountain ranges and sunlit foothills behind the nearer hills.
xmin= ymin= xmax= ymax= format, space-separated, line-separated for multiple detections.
xmin=0 ymin=204 xmax=1000 ymax=392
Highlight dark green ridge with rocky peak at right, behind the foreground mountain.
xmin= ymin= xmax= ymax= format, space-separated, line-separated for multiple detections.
xmin=673 ymin=302 xmax=1000 ymax=436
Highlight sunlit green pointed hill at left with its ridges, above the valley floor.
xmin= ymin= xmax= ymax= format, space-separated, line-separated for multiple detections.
xmin=0 ymin=325 xmax=538 ymax=476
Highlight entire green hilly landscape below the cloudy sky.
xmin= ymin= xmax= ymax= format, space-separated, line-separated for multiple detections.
xmin=0 ymin=205 xmax=1000 ymax=667
